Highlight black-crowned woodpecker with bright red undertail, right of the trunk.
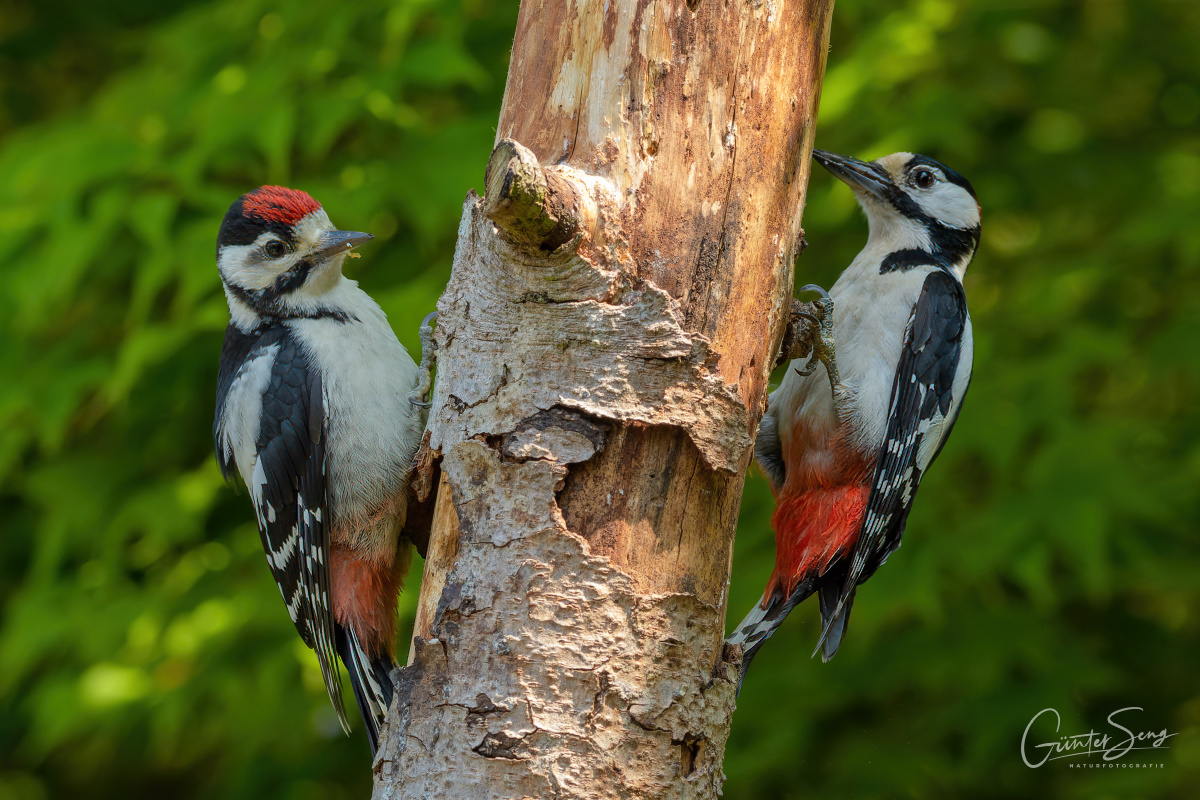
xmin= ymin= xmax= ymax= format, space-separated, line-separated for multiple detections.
xmin=727 ymin=150 xmax=980 ymax=678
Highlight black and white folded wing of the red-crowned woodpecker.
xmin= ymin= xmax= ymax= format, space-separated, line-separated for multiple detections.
xmin=217 ymin=327 xmax=349 ymax=730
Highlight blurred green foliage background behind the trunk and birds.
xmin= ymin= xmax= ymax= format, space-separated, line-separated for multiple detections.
xmin=0 ymin=0 xmax=1200 ymax=800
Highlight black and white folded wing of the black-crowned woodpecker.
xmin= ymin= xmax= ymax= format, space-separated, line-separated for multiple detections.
xmin=818 ymin=270 xmax=972 ymax=655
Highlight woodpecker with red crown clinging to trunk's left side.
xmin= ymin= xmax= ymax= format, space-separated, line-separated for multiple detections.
xmin=212 ymin=186 xmax=427 ymax=754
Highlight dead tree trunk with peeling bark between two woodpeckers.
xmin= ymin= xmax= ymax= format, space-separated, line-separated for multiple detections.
xmin=374 ymin=0 xmax=833 ymax=800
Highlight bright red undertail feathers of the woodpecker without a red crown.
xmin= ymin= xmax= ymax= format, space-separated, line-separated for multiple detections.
xmin=763 ymin=485 xmax=871 ymax=602
